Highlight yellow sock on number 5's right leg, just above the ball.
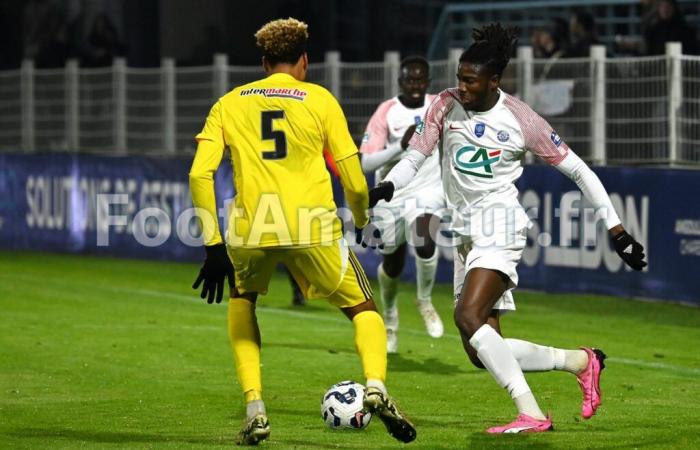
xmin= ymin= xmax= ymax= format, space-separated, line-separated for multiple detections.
xmin=352 ymin=311 xmax=386 ymax=382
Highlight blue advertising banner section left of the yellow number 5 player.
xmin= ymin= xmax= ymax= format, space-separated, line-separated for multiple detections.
xmin=0 ymin=154 xmax=221 ymax=260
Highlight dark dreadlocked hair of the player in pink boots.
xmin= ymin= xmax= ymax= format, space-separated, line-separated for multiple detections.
xmin=459 ymin=23 xmax=520 ymax=77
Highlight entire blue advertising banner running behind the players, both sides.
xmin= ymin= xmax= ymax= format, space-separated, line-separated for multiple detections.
xmin=0 ymin=154 xmax=700 ymax=304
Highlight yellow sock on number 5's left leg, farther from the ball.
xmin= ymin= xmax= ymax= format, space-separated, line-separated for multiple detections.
xmin=228 ymin=298 xmax=262 ymax=402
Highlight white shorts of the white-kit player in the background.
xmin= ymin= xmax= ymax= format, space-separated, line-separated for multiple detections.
xmin=371 ymin=186 xmax=445 ymax=255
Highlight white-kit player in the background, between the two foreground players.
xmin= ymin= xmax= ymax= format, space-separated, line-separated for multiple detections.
xmin=360 ymin=56 xmax=445 ymax=353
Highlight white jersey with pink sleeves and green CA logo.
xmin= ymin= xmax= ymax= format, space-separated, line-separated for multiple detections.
xmin=409 ymin=88 xmax=570 ymax=234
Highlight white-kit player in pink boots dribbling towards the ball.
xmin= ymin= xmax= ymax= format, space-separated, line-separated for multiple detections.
xmin=370 ymin=24 xmax=646 ymax=433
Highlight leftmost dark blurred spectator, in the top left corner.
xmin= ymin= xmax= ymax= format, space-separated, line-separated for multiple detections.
xmin=22 ymin=0 xmax=68 ymax=68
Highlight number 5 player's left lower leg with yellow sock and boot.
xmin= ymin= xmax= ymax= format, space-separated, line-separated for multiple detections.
xmin=228 ymin=288 xmax=270 ymax=445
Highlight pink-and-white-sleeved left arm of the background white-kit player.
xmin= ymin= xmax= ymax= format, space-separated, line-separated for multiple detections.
xmin=360 ymin=100 xmax=406 ymax=173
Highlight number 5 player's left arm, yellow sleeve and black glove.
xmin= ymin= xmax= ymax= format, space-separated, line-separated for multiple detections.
xmin=189 ymin=102 xmax=234 ymax=303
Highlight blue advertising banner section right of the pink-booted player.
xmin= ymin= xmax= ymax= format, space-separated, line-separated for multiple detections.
xmin=518 ymin=166 xmax=700 ymax=304
